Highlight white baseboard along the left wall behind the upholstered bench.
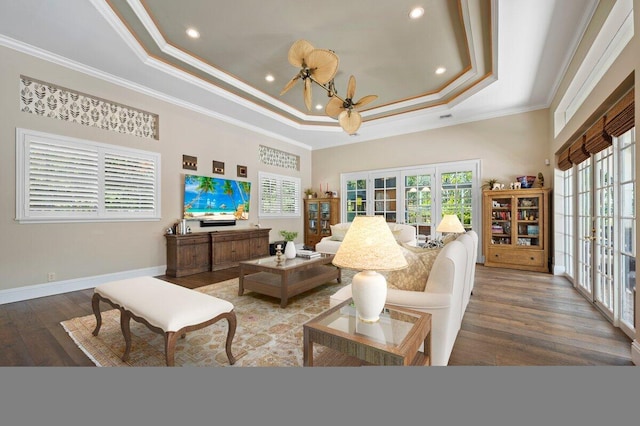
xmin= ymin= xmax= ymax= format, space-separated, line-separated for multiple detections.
xmin=0 ymin=265 xmax=167 ymax=305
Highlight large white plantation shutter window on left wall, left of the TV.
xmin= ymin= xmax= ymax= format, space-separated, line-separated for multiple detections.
xmin=16 ymin=129 xmax=160 ymax=223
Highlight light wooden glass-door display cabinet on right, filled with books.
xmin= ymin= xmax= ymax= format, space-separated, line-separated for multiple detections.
xmin=482 ymin=188 xmax=550 ymax=272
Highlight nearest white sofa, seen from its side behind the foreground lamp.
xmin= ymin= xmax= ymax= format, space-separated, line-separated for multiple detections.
xmin=329 ymin=234 xmax=477 ymax=366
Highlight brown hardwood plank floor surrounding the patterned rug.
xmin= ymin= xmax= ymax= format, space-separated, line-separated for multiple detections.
xmin=0 ymin=265 xmax=633 ymax=366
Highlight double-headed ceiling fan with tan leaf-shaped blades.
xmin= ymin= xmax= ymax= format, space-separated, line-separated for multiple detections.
xmin=280 ymin=40 xmax=378 ymax=135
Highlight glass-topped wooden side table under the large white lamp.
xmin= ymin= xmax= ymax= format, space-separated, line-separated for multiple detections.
xmin=303 ymin=299 xmax=431 ymax=367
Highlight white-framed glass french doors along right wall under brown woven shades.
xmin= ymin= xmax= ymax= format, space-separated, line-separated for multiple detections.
xmin=574 ymin=130 xmax=635 ymax=336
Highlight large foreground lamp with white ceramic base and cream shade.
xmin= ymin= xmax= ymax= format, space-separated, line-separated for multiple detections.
xmin=333 ymin=216 xmax=408 ymax=322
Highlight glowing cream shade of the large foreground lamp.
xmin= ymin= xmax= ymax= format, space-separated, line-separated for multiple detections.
xmin=333 ymin=216 xmax=407 ymax=271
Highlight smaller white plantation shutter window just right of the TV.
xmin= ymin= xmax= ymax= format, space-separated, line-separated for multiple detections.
xmin=258 ymin=172 xmax=302 ymax=217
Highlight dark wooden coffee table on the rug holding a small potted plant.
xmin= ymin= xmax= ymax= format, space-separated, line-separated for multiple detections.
xmin=238 ymin=254 xmax=341 ymax=308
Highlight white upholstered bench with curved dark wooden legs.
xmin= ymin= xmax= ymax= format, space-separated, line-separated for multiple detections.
xmin=91 ymin=277 xmax=236 ymax=366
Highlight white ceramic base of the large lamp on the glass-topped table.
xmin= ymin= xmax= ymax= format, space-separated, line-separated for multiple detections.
xmin=351 ymin=271 xmax=387 ymax=322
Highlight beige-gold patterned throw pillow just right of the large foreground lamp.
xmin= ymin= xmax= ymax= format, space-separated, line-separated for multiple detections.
xmin=386 ymin=243 xmax=440 ymax=291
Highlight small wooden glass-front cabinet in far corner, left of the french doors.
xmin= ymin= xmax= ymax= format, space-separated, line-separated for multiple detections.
xmin=304 ymin=198 xmax=340 ymax=249
